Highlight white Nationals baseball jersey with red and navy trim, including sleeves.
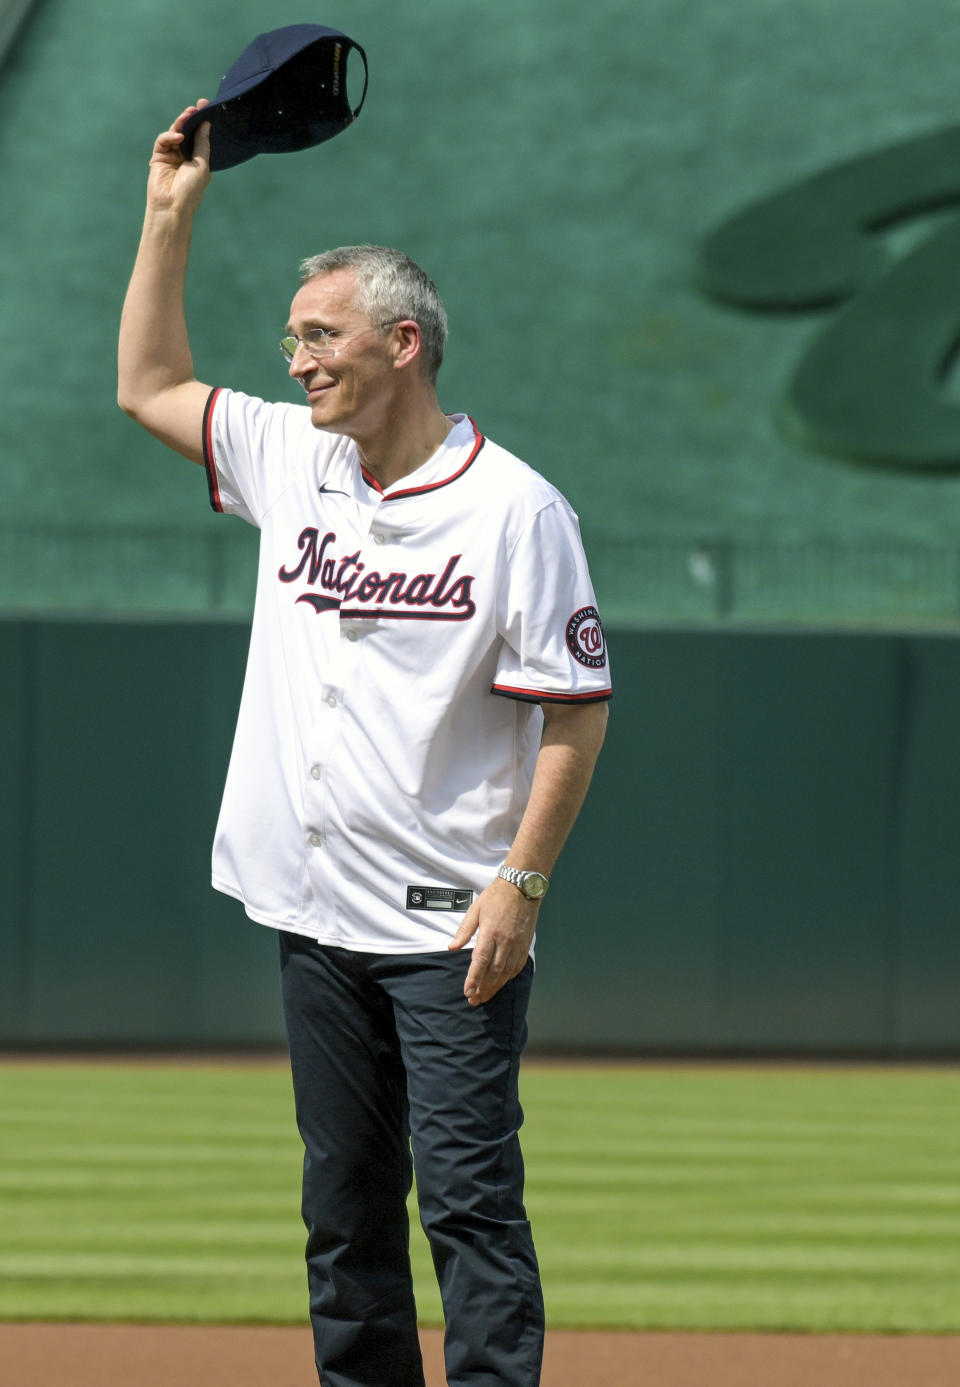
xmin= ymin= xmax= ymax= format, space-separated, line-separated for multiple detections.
xmin=204 ymin=390 xmax=610 ymax=953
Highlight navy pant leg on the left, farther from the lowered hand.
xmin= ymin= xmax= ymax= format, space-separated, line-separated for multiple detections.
xmin=280 ymin=933 xmax=423 ymax=1387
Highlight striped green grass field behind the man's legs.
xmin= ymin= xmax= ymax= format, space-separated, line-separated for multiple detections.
xmin=0 ymin=1062 xmax=960 ymax=1332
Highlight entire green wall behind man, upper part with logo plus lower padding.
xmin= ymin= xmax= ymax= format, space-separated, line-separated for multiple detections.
xmin=0 ymin=0 xmax=960 ymax=1054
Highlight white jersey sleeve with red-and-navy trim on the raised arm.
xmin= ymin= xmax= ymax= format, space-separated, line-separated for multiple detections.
xmin=203 ymin=390 xmax=309 ymax=528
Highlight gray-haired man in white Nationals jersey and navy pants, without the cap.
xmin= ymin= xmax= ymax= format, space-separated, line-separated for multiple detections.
xmin=119 ymin=107 xmax=609 ymax=1387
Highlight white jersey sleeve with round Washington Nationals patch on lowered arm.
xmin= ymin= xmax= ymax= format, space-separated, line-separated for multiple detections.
xmin=492 ymin=498 xmax=612 ymax=703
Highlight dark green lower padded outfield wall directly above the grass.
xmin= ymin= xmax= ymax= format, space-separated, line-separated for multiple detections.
xmin=0 ymin=619 xmax=960 ymax=1056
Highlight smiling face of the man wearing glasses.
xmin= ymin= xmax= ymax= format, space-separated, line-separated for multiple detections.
xmin=289 ymin=269 xmax=398 ymax=438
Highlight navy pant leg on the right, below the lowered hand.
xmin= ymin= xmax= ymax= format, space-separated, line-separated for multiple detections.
xmin=377 ymin=951 xmax=544 ymax=1387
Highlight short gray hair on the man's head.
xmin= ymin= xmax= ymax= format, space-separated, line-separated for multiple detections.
xmin=300 ymin=245 xmax=447 ymax=384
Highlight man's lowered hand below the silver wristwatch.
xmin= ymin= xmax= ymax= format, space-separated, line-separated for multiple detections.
xmin=449 ymin=877 xmax=540 ymax=1007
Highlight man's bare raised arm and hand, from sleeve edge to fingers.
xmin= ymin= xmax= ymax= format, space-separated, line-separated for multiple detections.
xmin=117 ymin=101 xmax=211 ymax=462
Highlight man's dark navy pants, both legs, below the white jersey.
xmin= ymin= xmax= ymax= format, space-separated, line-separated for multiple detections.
xmin=280 ymin=933 xmax=544 ymax=1387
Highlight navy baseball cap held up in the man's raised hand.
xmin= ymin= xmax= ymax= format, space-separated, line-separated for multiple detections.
xmin=180 ymin=24 xmax=368 ymax=172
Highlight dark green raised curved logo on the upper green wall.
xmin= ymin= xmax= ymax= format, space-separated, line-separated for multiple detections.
xmin=699 ymin=126 xmax=960 ymax=470
